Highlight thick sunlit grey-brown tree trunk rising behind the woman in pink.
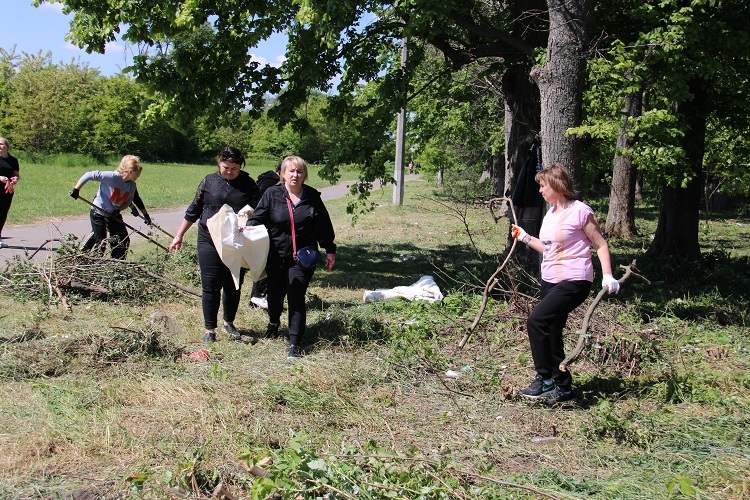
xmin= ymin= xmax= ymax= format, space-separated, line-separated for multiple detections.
xmin=532 ymin=0 xmax=593 ymax=186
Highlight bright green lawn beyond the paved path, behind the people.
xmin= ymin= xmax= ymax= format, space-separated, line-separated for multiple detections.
xmin=8 ymin=155 xmax=357 ymax=224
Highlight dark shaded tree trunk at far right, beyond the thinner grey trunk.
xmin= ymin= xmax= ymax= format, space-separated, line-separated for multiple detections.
xmin=647 ymin=79 xmax=709 ymax=260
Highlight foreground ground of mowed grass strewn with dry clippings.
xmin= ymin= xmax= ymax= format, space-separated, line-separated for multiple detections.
xmin=0 ymin=180 xmax=750 ymax=499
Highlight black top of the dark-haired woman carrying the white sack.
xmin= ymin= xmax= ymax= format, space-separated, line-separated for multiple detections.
xmin=185 ymin=170 xmax=260 ymax=232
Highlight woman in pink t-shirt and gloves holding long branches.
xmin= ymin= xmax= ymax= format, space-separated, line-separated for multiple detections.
xmin=511 ymin=163 xmax=620 ymax=405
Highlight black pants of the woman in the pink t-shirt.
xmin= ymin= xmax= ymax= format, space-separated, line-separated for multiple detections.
xmin=526 ymin=281 xmax=592 ymax=389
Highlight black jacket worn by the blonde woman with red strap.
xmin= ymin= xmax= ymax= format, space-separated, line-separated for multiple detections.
xmin=247 ymin=184 xmax=336 ymax=258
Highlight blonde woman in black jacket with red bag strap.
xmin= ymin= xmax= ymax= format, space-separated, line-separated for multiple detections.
xmin=247 ymin=156 xmax=336 ymax=358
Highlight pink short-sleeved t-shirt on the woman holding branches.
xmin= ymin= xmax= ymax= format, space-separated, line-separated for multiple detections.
xmin=539 ymin=200 xmax=594 ymax=283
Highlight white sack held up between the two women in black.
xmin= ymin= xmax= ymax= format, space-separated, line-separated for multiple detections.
xmin=206 ymin=205 xmax=269 ymax=290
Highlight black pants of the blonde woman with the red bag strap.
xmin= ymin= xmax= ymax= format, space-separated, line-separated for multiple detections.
xmin=266 ymin=249 xmax=315 ymax=346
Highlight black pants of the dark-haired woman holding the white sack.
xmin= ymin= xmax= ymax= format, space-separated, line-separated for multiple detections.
xmin=198 ymin=229 xmax=247 ymax=330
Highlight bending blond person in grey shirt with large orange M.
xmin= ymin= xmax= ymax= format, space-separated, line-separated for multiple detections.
xmin=70 ymin=155 xmax=151 ymax=259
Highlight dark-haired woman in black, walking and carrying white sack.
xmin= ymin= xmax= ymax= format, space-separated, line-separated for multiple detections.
xmin=169 ymin=147 xmax=260 ymax=343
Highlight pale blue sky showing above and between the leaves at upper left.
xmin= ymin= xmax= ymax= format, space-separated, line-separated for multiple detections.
xmin=0 ymin=0 xmax=286 ymax=76
